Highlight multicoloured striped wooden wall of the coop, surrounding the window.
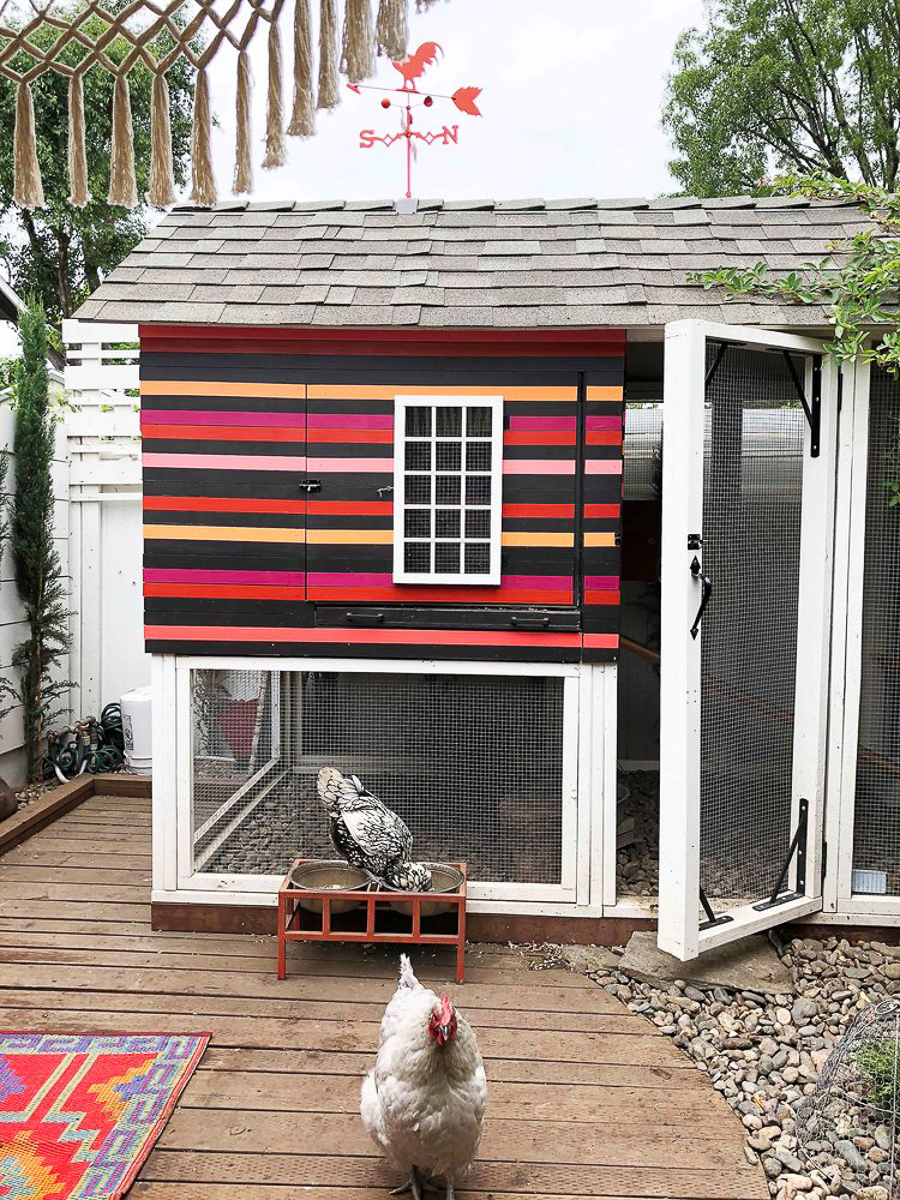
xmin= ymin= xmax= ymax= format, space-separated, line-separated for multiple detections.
xmin=140 ymin=328 xmax=624 ymax=661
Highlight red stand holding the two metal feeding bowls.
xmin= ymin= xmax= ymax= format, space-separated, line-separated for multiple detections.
xmin=278 ymin=858 xmax=468 ymax=983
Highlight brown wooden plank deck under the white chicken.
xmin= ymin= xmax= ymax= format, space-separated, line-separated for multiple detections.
xmin=0 ymin=796 xmax=768 ymax=1200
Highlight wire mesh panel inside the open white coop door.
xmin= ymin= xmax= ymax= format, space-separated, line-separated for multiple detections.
xmin=697 ymin=346 xmax=805 ymax=900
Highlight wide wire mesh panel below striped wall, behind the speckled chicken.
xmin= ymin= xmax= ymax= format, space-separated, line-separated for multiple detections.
xmin=191 ymin=670 xmax=564 ymax=884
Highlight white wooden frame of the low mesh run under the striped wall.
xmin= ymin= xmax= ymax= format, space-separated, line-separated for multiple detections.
xmin=152 ymin=655 xmax=616 ymax=916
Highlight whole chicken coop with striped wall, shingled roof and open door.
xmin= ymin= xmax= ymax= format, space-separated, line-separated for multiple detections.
xmin=72 ymin=189 xmax=900 ymax=958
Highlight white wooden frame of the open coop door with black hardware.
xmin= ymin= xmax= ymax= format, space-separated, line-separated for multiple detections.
xmin=659 ymin=320 xmax=838 ymax=960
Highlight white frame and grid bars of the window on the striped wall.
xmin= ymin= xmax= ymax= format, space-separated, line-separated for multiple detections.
xmin=394 ymin=395 xmax=503 ymax=587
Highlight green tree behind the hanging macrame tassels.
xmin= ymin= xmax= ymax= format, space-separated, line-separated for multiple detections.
xmin=0 ymin=0 xmax=193 ymax=325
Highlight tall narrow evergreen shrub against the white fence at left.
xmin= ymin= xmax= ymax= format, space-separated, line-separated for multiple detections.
xmin=0 ymin=300 xmax=70 ymax=780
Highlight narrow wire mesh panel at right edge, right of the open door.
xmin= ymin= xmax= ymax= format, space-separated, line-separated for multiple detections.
xmin=852 ymin=368 xmax=900 ymax=895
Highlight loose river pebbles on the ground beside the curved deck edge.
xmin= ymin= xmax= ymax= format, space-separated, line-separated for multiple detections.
xmin=542 ymin=937 xmax=900 ymax=1200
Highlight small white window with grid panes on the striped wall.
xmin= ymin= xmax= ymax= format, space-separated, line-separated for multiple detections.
xmin=394 ymin=396 xmax=503 ymax=584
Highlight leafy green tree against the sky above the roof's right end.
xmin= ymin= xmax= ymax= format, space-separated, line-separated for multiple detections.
xmin=662 ymin=0 xmax=900 ymax=196
